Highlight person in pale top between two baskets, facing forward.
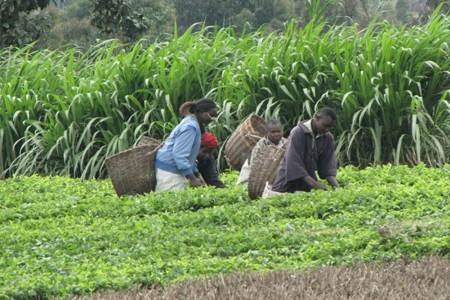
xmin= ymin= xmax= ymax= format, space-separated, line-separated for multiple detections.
xmin=236 ymin=119 xmax=287 ymax=185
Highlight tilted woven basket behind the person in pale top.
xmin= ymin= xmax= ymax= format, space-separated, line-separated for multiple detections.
xmin=225 ymin=113 xmax=266 ymax=171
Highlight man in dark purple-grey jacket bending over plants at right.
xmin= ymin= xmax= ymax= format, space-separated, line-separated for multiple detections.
xmin=262 ymin=107 xmax=339 ymax=198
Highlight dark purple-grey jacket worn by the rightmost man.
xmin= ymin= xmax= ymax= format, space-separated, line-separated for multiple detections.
xmin=272 ymin=122 xmax=337 ymax=193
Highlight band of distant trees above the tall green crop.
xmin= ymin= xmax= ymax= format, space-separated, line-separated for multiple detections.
xmin=0 ymin=0 xmax=448 ymax=49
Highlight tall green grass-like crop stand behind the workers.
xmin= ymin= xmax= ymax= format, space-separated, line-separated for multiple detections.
xmin=0 ymin=13 xmax=450 ymax=179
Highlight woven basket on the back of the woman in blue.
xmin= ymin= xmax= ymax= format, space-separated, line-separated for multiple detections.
xmin=105 ymin=145 xmax=159 ymax=197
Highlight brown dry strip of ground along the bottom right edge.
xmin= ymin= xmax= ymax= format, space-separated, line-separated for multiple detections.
xmin=73 ymin=257 xmax=450 ymax=300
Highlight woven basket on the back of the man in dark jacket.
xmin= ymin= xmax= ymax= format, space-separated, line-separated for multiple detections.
xmin=248 ymin=145 xmax=286 ymax=200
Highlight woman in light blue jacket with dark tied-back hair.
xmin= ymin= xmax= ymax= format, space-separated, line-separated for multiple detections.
xmin=155 ymin=99 xmax=217 ymax=192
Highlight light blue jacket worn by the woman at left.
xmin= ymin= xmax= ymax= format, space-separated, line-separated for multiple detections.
xmin=155 ymin=115 xmax=201 ymax=176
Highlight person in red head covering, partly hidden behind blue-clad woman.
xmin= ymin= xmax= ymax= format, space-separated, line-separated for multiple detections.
xmin=197 ymin=132 xmax=227 ymax=189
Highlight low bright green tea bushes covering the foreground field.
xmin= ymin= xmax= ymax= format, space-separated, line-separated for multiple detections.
xmin=0 ymin=164 xmax=450 ymax=299
